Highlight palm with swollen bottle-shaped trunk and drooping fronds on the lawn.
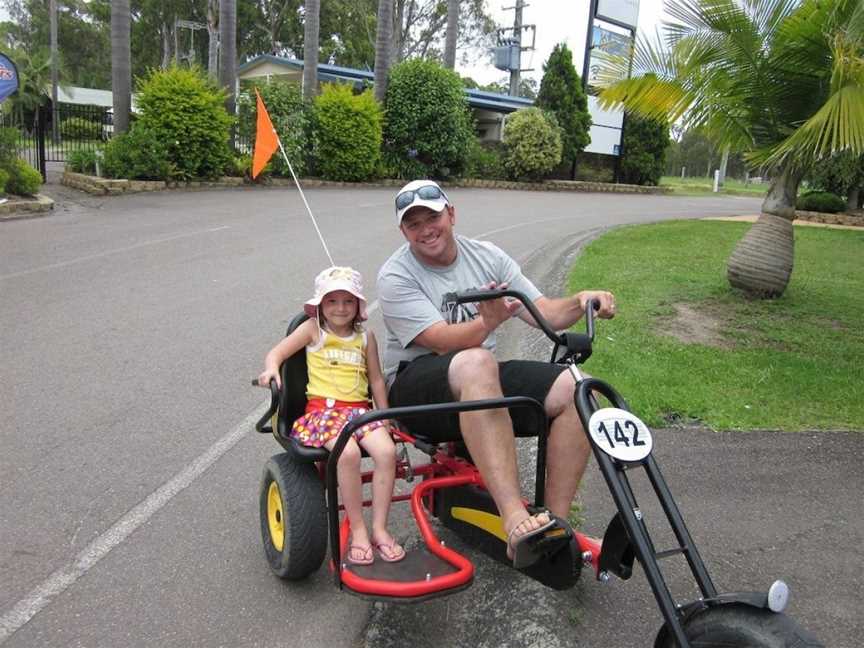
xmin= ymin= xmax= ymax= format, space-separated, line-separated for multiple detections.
xmin=600 ymin=0 xmax=864 ymax=298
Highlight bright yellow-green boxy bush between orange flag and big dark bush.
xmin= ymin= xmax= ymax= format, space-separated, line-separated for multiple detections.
xmin=313 ymin=84 xmax=382 ymax=181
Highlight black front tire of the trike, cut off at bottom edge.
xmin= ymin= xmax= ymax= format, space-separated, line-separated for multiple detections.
xmin=655 ymin=603 xmax=824 ymax=648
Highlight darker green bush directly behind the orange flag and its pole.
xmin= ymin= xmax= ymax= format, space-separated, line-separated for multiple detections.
xmin=237 ymin=80 xmax=311 ymax=177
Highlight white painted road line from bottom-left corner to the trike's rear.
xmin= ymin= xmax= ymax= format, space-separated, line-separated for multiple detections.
xmin=0 ymin=398 xmax=270 ymax=644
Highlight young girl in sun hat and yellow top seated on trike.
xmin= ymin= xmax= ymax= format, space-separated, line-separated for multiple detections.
xmin=258 ymin=266 xmax=405 ymax=565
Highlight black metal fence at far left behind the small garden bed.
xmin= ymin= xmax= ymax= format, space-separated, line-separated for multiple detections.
xmin=0 ymin=104 xmax=114 ymax=180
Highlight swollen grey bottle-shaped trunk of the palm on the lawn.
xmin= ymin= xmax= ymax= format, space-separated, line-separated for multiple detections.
xmin=726 ymin=169 xmax=801 ymax=299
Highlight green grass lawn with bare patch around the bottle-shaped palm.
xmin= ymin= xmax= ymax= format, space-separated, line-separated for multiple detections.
xmin=569 ymin=221 xmax=864 ymax=431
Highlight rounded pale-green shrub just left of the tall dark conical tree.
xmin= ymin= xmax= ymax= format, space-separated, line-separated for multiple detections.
xmin=504 ymin=108 xmax=562 ymax=180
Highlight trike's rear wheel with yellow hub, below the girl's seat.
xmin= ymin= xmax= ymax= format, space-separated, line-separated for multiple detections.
xmin=258 ymin=452 xmax=327 ymax=580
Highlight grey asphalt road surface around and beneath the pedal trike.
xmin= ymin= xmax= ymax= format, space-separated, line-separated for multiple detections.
xmin=0 ymin=189 xmax=864 ymax=647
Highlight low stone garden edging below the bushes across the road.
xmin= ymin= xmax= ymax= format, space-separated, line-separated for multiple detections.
xmin=61 ymin=171 xmax=671 ymax=196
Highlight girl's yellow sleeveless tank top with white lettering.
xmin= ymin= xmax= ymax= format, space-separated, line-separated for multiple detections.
xmin=306 ymin=328 xmax=369 ymax=401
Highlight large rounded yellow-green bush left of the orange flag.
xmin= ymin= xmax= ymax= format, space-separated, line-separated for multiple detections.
xmin=135 ymin=67 xmax=234 ymax=179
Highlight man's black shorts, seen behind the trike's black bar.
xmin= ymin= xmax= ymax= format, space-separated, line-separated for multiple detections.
xmin=388 ymin=351 xmax=567 ymax=442
